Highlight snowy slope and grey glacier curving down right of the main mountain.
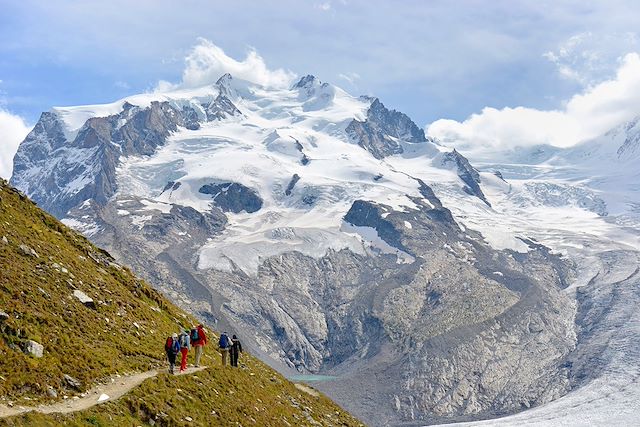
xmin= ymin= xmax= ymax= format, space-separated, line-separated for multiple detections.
xmin=428 ymin=119 xmax=640 ymax=426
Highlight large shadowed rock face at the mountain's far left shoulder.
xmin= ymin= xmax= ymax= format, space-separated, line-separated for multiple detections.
xmin=11 ymin=102 xmax=202 ymax=217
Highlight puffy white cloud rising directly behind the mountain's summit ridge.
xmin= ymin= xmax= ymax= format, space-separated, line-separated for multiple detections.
xmin=156 ymin=38 xmax=296 ymax=92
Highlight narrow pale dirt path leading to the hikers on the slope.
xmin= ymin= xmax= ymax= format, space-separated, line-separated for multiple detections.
xmin=0 ymin=366 xmax=207 ymax=418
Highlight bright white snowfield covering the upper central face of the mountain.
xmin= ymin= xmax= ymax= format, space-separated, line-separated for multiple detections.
xmin=114 ymin=75 xmax=460 ymax=274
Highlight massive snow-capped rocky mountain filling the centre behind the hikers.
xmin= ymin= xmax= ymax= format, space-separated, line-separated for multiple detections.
xmin=12 ymin=75 xmax=631 ymax=425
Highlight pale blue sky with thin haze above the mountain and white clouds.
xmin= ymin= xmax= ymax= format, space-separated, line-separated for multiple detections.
xmin=0 ymin=0 xmax=640 ymax=175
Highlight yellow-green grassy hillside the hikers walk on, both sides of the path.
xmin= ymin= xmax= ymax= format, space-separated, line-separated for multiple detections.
xmin=0 ymin=180 xmax=360 ymax=426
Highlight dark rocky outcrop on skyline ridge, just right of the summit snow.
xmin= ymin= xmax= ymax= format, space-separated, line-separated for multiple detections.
xmin=346 ymin=98 xmax=427 ymax=159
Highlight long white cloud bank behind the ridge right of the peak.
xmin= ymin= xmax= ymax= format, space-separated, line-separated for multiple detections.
xmin=427 ymin=53 xmax=640 ymax=153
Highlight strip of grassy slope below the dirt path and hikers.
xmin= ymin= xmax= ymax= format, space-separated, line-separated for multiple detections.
xmin=7 ymin=359 xmax=361 ymax=426
